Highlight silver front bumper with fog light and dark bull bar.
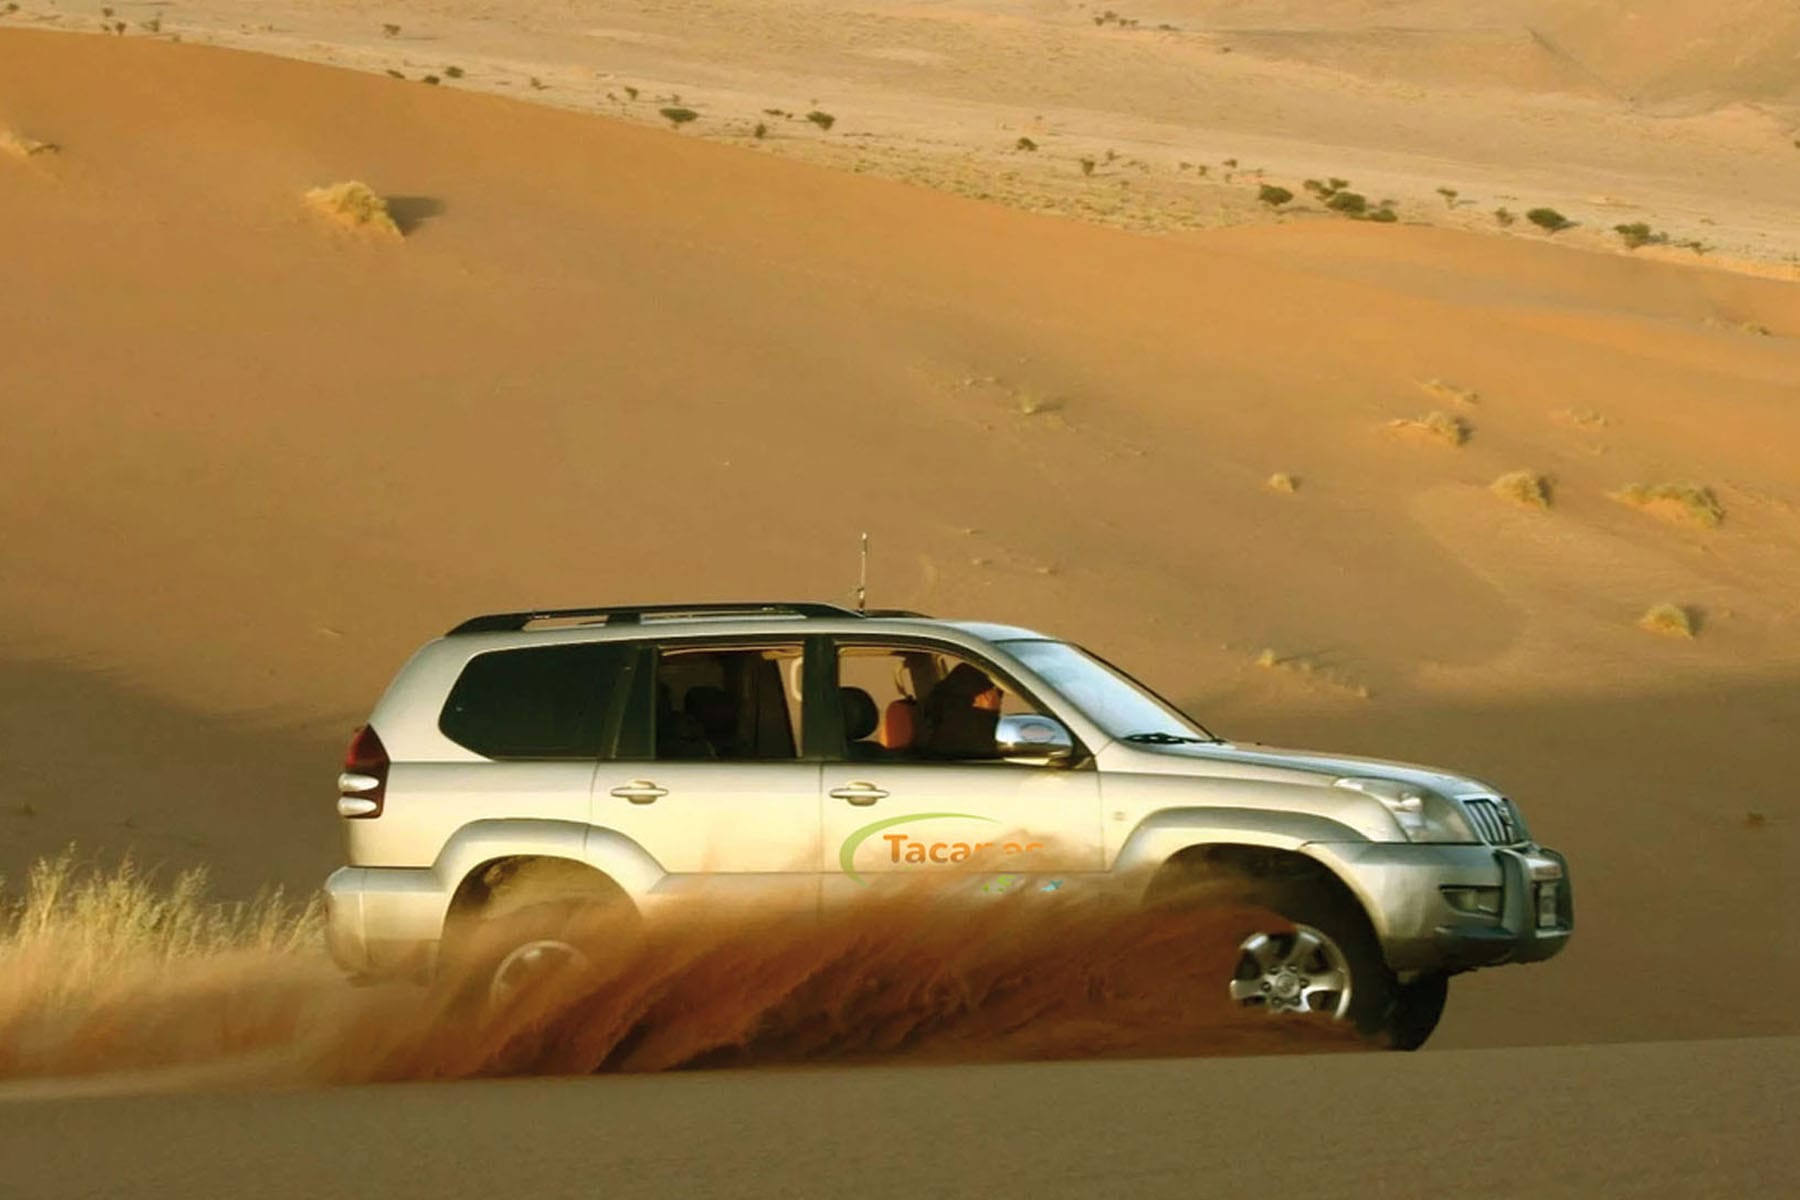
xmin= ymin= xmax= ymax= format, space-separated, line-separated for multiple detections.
xmin=1307 ymin=842 xmax=1575 ymax=972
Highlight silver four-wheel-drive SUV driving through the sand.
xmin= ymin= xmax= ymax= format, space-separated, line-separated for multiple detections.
xmin=326 ymin=603 xmax=1573 ymax=1047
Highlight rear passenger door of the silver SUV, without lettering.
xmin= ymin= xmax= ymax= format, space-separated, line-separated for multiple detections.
xmin=592 ymin=637 xmax=819 ymax=905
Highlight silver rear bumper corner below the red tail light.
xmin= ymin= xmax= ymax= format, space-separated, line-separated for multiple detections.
xmin=324 ymin=867 xmax=450 ymax=977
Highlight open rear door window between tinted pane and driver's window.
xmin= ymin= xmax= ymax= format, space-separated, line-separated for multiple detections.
xmin=644 ymin=644 xmax=803 ymax=763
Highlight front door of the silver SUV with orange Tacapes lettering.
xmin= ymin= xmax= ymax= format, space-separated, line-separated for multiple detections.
xmin=821 ymin=640 xmax=1103 ymax=901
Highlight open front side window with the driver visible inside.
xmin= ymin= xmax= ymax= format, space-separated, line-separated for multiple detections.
xmin=837 ymin=644 xmax=1040 ymax=763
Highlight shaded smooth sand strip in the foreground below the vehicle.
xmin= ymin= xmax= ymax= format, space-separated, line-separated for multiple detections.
xmin=0 ymin=1038 xmax=1800 ymax=1200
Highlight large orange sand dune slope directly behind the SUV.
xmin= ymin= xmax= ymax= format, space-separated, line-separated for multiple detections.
xmin=0 ymin=31 xmax=1800 ymax=1045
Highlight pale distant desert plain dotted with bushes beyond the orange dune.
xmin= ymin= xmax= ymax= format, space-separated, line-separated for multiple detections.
xmin=0 ymin=0 xmax=1800 ymax=262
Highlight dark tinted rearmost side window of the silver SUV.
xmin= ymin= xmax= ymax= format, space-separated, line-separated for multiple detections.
xmin=437 ymin=642 xmax=623 ymax=759
